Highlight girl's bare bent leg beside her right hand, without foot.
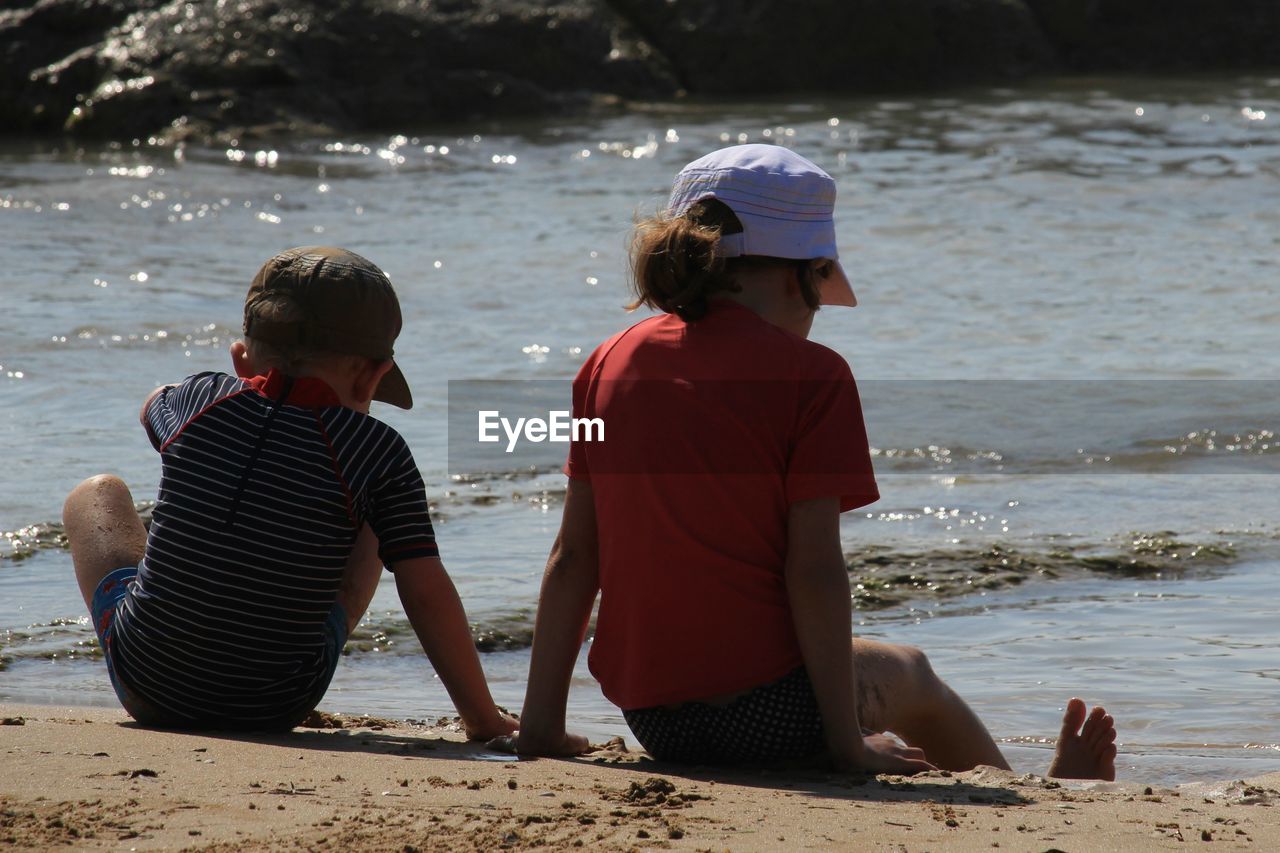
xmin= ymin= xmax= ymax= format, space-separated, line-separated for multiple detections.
xmin=854 ymin=639 xmax=1009 ymax=770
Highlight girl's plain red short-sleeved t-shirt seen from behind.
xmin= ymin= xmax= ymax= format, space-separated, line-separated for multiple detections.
xmin=564 ymin=301 xmax=879 ymax=710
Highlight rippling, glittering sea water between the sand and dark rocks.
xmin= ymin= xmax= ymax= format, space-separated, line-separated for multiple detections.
xmin=0 ymin=77 xmax=1280 ymax=781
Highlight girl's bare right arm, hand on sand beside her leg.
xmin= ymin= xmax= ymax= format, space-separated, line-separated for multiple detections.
xmin=786 ymin=497 xmax=933 ymax=774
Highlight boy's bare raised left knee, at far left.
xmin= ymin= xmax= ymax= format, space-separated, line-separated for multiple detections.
xmin=63 ymin=474 xmax=147 ymax=607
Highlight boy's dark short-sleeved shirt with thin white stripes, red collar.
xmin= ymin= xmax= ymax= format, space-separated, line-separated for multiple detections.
xmin=111 ymin=370 xmax=439 ymax=725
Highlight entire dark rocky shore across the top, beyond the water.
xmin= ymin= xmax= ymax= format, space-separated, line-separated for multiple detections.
xmin=0 ymin=0 xmax=1280 ymax=140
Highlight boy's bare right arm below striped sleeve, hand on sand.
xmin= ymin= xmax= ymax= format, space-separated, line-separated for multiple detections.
xmin=396 ymin=557 xmax=518 ymax=740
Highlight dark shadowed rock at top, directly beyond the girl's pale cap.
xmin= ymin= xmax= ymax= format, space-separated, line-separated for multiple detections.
xmin=612 ymin=0 xmax=1052 ymax=93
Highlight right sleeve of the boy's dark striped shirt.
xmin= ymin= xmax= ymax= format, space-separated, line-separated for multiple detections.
xmin=369 ymin=433 xmax=440 ymax=571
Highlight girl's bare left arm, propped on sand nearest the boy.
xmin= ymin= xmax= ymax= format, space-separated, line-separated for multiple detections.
xmin=516 ymin=480 xmax=600 ymax=756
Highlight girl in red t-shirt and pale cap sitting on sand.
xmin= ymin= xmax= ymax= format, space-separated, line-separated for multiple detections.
xmin=516 ymin=145 xmax=1115 ymax=779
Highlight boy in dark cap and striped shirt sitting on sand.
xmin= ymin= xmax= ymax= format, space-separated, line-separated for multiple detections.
xmin=63 ymin=247 xmax=516 ymax=739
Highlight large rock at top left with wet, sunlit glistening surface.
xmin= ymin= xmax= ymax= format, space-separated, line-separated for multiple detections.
xmin=0 ymin=0 xmax=675 ymax=138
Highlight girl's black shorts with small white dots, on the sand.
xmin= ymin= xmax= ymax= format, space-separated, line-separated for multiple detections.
xmin=622 ymin=667 xmax=827 ymax=765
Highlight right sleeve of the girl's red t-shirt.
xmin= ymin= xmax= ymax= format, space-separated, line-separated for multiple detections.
xmin=786 ymin=353 xmax=879 ymax=512
